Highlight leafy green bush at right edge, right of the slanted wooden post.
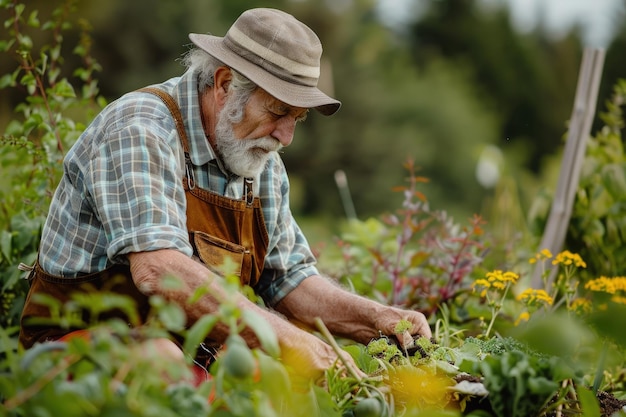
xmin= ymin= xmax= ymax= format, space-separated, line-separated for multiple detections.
xmin=530 ymin=79 xmax=626 ymax=282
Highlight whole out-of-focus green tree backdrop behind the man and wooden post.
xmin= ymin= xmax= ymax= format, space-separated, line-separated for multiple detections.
xmin=0 ymin=0 xmax=626 ymax=241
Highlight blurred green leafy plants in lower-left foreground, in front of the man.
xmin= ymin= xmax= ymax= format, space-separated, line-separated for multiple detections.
xmin=0 ymin=277 xmax=340 ymax=417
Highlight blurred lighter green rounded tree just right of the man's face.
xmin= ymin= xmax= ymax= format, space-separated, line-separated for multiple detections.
xmin=276 ymin=0 xmax=498 ymax=216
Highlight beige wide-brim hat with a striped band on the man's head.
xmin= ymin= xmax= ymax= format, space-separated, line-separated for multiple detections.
xmin=189 ymin=8 xmax=341 ymax=116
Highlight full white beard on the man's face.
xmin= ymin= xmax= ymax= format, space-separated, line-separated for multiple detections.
xmin=215 ymin=102 xmax=282 ymax=178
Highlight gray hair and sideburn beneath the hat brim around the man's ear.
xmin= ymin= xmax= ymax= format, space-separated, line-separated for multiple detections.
xmin=181 ymin=48 xmax=258 ymax=123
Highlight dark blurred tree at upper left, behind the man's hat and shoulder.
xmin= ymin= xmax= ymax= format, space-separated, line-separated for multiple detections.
xmin=84 ymin=0 xmax=285 ymax=97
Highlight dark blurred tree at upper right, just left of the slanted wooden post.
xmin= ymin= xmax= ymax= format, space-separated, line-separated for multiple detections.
xmin=404 ymin=0 xmax=582 ymax=172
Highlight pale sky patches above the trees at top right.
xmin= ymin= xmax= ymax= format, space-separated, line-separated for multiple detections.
xmin=378 ymin=0 xmax=626 ymax=47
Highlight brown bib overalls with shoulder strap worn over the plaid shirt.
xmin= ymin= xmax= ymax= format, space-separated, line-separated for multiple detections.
xmin=19 ymin=88 xmax=269 ymax=354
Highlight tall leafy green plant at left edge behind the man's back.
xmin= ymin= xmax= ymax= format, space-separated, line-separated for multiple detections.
xmin=0 ymin=0 xmax=105 ymax=327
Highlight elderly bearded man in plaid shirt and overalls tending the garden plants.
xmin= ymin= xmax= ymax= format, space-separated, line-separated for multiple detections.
xmin=20 ymin=9 xmax=431 ymax=380
